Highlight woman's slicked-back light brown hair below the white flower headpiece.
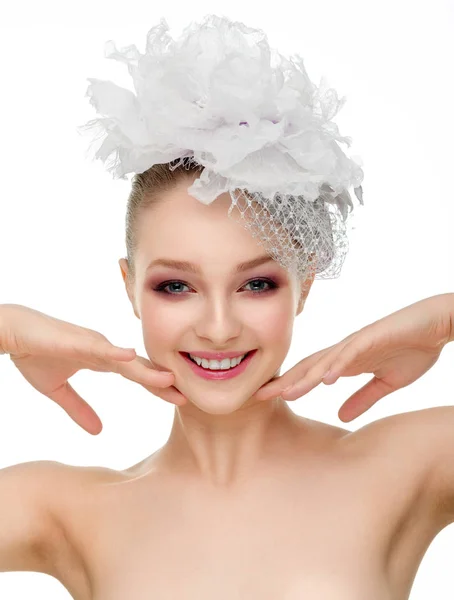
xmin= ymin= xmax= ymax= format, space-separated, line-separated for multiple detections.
xmin=126 ymin=158 xmax=205 ymax=283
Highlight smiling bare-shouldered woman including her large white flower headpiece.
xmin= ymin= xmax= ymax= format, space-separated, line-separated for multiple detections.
xmin=0 ymin=11 xmax=454 ymax=600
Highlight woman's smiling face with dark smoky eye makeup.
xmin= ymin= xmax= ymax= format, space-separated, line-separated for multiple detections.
xmin=120 ymin=180 xmax=307 ymax=414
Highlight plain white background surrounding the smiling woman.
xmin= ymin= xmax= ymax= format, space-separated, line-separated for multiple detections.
xmin=0 ymin=0 xmax=454 ymax=600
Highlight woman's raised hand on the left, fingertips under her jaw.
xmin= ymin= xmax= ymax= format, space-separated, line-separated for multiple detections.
xmin=0 ymin=304 xmax=186 ymax=435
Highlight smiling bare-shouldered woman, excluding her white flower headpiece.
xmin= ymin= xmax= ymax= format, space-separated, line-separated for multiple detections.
xmin=0 ymin=157 xmax=454 ymax=600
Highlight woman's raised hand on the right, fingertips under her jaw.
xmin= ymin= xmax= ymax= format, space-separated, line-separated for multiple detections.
xmin=254 ymin=294 xmax=454 ymax=422
